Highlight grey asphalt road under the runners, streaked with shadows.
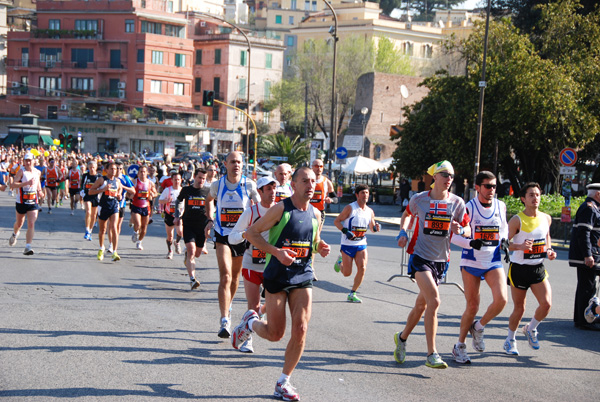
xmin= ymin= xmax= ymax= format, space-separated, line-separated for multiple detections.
xmin=0 ymin=193 xmax=600 ymax=401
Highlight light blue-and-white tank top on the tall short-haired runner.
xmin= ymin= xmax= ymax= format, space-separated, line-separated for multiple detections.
xmin=215 ymin=176 xmax=251 ymax=236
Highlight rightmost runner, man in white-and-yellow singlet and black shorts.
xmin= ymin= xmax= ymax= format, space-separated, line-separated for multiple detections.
xmin=504 ymin=182 xmax=556 ymax=355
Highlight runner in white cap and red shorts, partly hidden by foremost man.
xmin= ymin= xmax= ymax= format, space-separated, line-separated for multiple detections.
xmin=229 ymin=176 xmax=277 ymax=353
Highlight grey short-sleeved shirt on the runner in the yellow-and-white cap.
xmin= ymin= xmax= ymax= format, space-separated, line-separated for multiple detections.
xmin=407 ymin=191 xmax=469 ymax=262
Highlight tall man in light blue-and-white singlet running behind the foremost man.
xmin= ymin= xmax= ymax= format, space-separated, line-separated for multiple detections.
xmin=206 ymin=152 xmax=260 ymax=338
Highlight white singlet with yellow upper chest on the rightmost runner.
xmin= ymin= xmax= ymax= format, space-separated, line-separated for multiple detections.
xmin=510 ymin=212 xmax=550 ymax=265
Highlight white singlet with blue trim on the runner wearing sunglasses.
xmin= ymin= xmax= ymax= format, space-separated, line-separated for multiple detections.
xmin=460 ymin=198 xmax=508 ymax=269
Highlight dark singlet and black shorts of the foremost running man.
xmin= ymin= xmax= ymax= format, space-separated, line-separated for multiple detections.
xmin=264 ymin=198 xmax=319 ymax=285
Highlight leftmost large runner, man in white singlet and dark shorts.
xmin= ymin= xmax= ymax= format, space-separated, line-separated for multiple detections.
xmin=8 ymin=152 xmax=44 ymax=255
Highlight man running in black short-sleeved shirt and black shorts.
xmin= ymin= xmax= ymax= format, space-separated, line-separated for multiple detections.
xmin=173 ymin=169 xmax=212 ymax=290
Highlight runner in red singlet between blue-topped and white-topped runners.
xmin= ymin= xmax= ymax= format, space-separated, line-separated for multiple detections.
xmin=131 ymin=166 xmax=156 ymax=250
